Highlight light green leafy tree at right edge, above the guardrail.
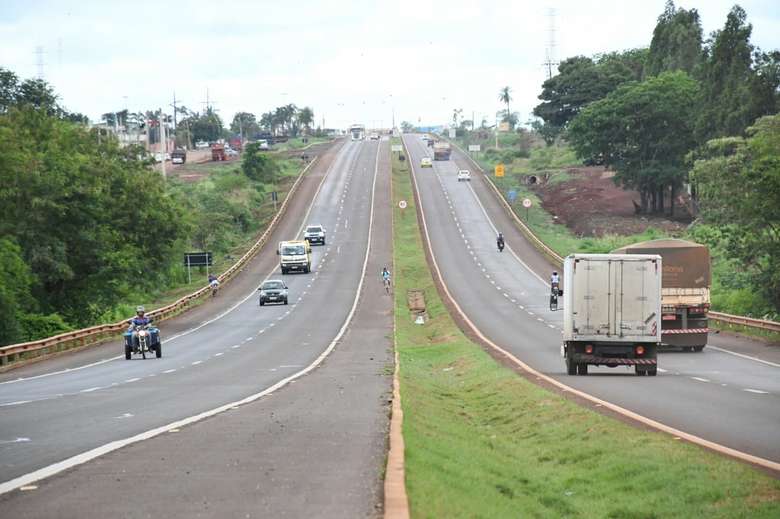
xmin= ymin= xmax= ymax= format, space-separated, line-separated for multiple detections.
xmin=691 ymin=115 xmax=780 ymax=308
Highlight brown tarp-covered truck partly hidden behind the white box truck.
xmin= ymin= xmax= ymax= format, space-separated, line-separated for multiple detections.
xmin=612 ymin=239 xmax=712 ymax=351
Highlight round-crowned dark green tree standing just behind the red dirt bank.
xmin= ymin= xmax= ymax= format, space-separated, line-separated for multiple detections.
xmin=569 ymin=71 xmax=698 ymax=214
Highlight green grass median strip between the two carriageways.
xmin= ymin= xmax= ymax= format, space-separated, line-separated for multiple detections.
xmin=393 ymin=142 xmax=780 ymax=518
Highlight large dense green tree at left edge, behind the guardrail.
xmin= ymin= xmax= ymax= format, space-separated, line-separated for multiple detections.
xmin=0 ymin=106 xmax=187 ymax=325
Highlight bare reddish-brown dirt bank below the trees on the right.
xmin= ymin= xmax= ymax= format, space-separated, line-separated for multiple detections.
xmin=534 ymin=166 xmax=690 ymax=236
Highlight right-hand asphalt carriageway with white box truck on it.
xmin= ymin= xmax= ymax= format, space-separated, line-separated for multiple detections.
xmin=404 ymin=135 xmax=780 ymax=462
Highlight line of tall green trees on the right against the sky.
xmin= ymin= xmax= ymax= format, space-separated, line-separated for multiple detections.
xmin=534 ymin=1 xmax=780 ymax=309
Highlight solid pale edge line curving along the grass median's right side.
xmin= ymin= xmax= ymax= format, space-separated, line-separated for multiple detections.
xmin=402 ymin=137 xmax=780 ymax=472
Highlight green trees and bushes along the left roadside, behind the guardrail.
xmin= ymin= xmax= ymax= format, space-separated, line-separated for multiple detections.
xmin=0 ymin=69 xmax=310 ymax=345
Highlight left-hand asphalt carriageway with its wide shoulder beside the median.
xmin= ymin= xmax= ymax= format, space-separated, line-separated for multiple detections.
xmin=0 ymin=137 xmax=392 ymax=517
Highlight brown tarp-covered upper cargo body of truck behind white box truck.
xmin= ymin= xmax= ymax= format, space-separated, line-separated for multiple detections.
xmin=612 ymin=239 xmax=711 ymax=288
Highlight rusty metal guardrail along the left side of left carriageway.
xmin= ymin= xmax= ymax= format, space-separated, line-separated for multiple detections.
xmin=0 ymin=157 xmax=317 ymax=371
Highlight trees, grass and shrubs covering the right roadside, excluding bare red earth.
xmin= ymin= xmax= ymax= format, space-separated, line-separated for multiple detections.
xmin=453 ymin=1 xmax=780 ymax=320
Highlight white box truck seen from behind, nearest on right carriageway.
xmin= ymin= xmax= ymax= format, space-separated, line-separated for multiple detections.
xmin=561 ymin=254 xmax=663 ymax=376
